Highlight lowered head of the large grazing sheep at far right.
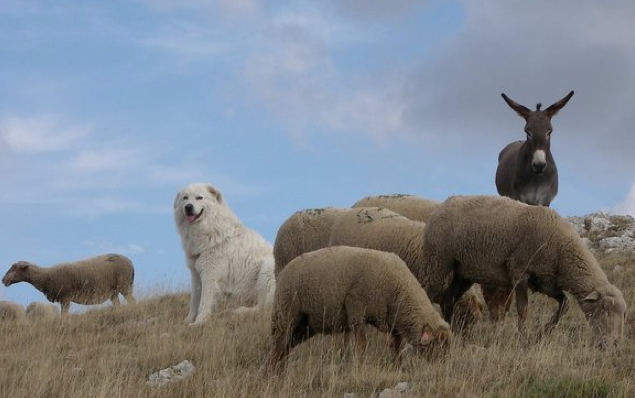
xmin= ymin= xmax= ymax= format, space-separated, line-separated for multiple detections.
xmin=580 ymin=286 xmax=626 ymax=349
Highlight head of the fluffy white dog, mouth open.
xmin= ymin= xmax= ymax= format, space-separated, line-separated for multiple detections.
xmin=174 ymin=183 xmax=225 ymax=225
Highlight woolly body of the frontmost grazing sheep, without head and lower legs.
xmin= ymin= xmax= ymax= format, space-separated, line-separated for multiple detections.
xmin=274 ymin=246 xmax=408 ymax=333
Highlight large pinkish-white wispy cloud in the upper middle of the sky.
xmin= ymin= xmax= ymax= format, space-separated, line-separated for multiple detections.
xmin=244 ymin=8 xmax=403 ymax=139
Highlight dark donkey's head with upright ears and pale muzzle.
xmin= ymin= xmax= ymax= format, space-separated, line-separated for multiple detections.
xmin=501 ymin=91 xmax=573 ymax=174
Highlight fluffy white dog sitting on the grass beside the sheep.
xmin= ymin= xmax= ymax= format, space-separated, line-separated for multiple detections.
xmin=174 ymin=183 xmax=275 ymax=324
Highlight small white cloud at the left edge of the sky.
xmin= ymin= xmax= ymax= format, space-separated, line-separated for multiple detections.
xmin=0 ymin=116 xmax=91 ymax=153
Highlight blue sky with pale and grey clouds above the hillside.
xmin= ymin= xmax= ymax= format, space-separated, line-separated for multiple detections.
xmin=0 ymin=0 xmax=635 ymax=310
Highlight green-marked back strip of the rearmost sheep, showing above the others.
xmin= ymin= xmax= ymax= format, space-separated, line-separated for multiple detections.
xmin=352 ymin=194 xmax=439 ymax=222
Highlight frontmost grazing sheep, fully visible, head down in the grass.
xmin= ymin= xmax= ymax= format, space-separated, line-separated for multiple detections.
xmin=268 ymin=246 xmax=452 ymax=370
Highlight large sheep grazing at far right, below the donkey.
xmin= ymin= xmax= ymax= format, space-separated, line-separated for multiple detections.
xmin=421 ymin=196 xmax=626 ymax=348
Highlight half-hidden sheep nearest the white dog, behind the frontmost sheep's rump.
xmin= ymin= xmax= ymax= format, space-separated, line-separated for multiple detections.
xmin=273 ymin=207 xmax=348 ymax=276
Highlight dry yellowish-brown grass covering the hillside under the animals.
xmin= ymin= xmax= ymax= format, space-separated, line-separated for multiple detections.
xmin=0 ymin=252 xmax=635 ymax=398
